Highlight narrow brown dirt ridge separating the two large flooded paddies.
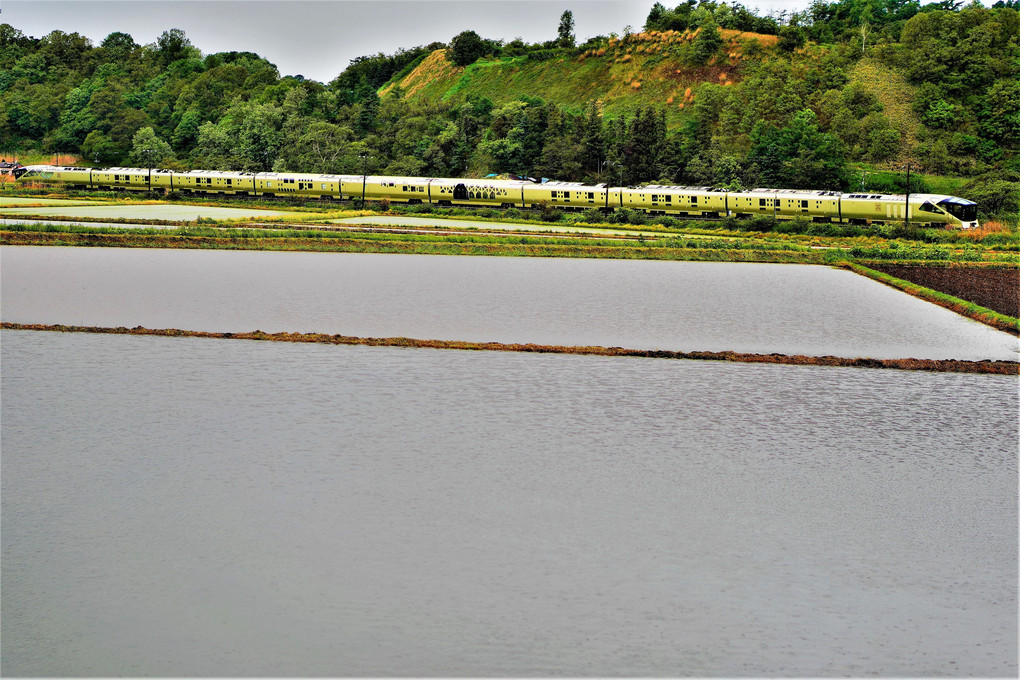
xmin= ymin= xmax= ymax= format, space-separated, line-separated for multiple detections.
xmin=0 ymin=321 xmax=1020 ymax=375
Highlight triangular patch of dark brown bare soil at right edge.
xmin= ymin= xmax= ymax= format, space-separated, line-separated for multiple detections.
xmin=868 ymin=264 xmax=1020 ymax=318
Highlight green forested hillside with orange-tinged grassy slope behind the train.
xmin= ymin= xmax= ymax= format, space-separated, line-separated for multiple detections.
xmin=0 ymin=0 xmax=1020 ymax=212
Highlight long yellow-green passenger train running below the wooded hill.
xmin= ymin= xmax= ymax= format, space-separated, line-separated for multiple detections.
xmin=15 ymin=165 xmax=978 ymax=229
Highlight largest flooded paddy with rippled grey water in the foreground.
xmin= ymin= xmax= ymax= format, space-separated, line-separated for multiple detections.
xmin=0 ymin=330 xmax=1018 ymax=677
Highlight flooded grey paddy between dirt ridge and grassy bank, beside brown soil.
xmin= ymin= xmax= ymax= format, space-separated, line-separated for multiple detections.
xmin=0 ymin=247 xmax=1018 ymax=360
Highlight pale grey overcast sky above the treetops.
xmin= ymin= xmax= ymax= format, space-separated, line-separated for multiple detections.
xmin=0 ymin=0 xmax=808 ymax=83
